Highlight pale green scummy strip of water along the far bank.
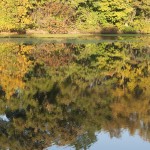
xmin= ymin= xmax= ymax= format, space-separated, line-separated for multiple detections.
xmin=0 ymin=34 xmax=150 ymax=44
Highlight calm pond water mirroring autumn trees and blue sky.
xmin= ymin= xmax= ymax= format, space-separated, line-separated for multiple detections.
xmin=0 ymin=36 xmax=150 ymax=150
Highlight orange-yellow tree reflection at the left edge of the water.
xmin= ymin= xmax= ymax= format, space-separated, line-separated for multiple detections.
xmin=0 ymin=44 xmax=31 ymax=99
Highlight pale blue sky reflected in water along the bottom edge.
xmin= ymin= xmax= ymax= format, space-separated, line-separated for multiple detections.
xmin=45 ymin=130 xmax=150 ymax=150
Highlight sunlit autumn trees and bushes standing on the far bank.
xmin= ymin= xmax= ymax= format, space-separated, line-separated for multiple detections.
xmin=0 ymin=0 xmax=150 ymax=34
